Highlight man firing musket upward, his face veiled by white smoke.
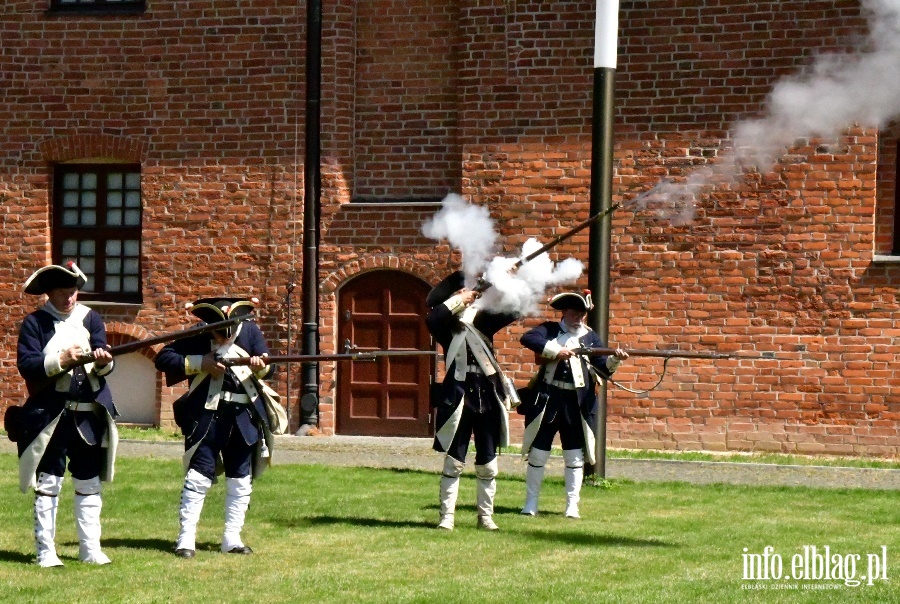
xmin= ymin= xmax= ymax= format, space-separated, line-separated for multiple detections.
xmin=426 ymin=271 xmax=519 ymax=530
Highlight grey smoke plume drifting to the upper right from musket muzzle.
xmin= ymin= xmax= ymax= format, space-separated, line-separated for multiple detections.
xmin=660 ymin=0 xmax=900 ymax=218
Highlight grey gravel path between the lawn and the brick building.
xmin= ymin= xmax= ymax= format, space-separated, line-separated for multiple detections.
xmin=0 ymin=436 xmax=900 ymax=490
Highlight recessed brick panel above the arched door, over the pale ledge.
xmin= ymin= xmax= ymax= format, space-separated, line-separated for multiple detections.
xmin=353 ymin=0 xmax=460 ymax=199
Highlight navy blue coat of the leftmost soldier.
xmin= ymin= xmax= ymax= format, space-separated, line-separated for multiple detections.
xmin=16 ymin=309 xmax=118 ymax=454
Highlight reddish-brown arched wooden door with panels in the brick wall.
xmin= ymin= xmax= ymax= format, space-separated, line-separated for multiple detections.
xmin=336 ymin=270 xmax=436 ymax=436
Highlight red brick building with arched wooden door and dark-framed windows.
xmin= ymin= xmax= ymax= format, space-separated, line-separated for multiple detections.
xmin=0 ymin=0 xmax=900 ymax=456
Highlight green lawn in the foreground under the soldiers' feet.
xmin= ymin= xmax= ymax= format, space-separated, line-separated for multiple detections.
xmin=0 ymin=454 xmax=900 ymax=604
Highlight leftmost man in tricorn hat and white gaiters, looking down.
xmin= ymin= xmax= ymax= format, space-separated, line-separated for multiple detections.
xmin=13 ymin=263 xmax=118 ymax=567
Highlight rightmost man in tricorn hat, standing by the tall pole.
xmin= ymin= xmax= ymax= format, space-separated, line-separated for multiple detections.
xmin=517 ymin=291 xmax=628 ymax=518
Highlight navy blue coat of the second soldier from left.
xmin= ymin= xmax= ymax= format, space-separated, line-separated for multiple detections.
xmin=155 ymin=321 xmax=274 ymax=449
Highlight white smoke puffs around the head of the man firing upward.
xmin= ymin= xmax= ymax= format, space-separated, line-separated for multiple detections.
xmin=422 ymin=194 xmax=584 ymax=314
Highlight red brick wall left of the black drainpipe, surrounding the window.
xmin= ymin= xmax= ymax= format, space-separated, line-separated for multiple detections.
xmin=0 ymin=0 xmax=305 ymax=420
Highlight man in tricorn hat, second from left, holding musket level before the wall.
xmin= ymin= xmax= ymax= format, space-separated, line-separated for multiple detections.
xmin=156 ymin=297 xmax=273 ymax=558
